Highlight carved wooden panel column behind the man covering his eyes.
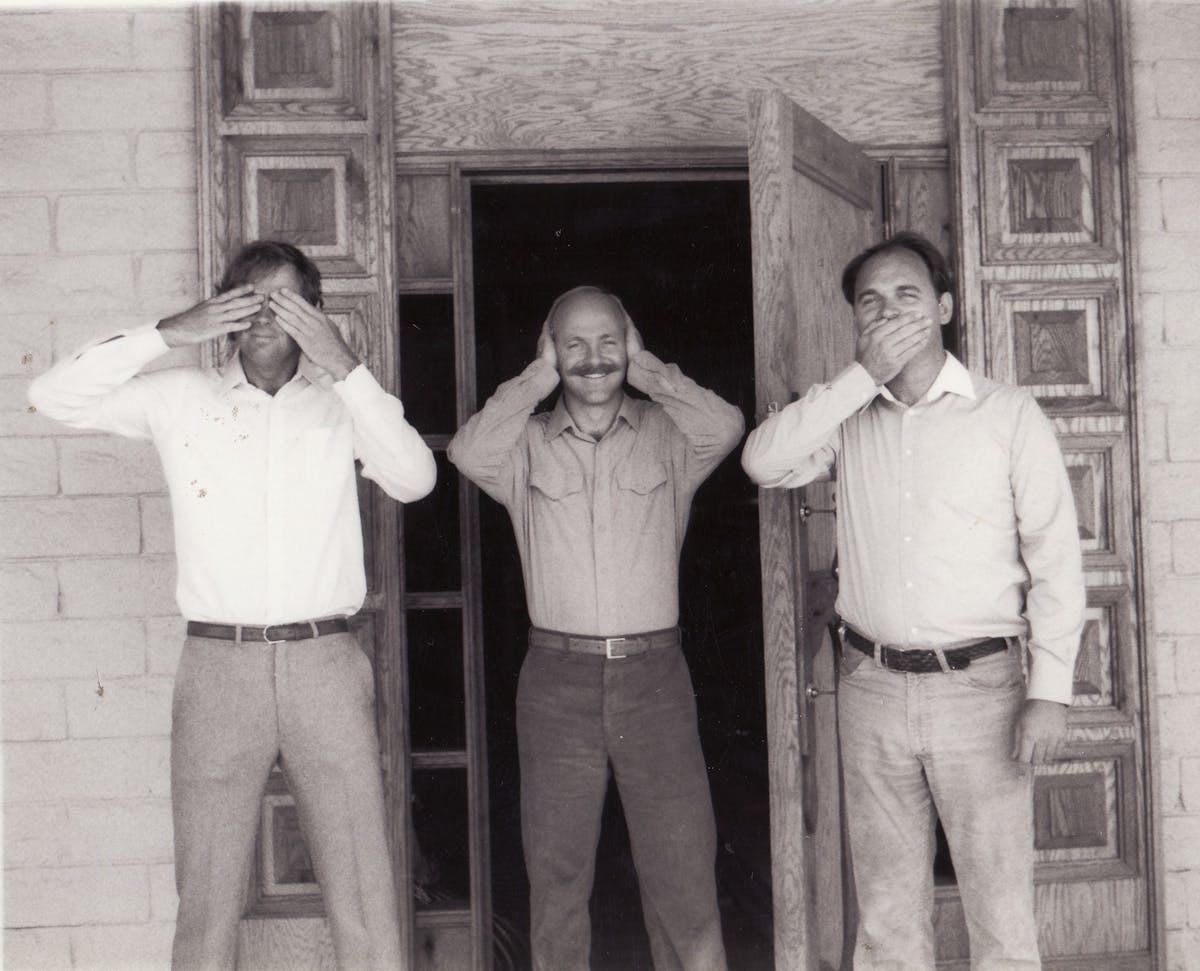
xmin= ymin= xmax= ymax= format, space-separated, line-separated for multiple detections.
xmin=197 ymin=2 xmax=413 ymax=967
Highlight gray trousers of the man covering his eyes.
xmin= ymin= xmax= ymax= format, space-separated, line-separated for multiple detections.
xmin=170 ymin=634 xmax=402 ymax=970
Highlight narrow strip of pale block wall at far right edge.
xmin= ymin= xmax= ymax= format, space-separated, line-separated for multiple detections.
xmin=1129 ymin=0 xmax=1200 ymax=971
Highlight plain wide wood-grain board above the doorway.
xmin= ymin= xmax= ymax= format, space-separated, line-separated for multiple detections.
xmin=395 ymin=0 xmax=944 ymax=152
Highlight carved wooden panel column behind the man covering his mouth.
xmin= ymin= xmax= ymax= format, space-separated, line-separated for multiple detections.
xmin=938 ymin=0 xmax=1153 ymax=971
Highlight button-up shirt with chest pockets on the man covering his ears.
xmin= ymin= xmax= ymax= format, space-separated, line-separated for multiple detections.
xmin=449 ymin=350 xmax=744 ymax=637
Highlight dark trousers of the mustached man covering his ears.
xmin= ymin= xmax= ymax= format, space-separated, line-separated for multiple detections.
xmin=517 ymin=646 xmax=725 ymax=971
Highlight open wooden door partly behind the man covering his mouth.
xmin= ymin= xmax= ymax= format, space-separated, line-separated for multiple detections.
xmin=749 ymin=91 xmax=880 ymax=971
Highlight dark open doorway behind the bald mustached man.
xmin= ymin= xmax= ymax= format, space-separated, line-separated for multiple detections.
xmin=470 ymin=176 xmax=774 ymax=971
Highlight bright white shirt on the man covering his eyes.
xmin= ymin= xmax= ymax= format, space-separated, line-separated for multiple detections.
xmin=29 ymin=326 xmax=437 ymax=625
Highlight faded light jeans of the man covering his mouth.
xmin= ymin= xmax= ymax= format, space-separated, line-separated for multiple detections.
xmin=838 ymin=640 xmax=1042 ymax=971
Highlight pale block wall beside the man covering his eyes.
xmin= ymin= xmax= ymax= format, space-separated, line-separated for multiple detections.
xmin=0 ymin=5 xmax=198 ymax=969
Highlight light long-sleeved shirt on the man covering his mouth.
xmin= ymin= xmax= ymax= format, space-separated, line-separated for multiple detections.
xmin=742 ymin=354 xmax=1086 ymax=705
